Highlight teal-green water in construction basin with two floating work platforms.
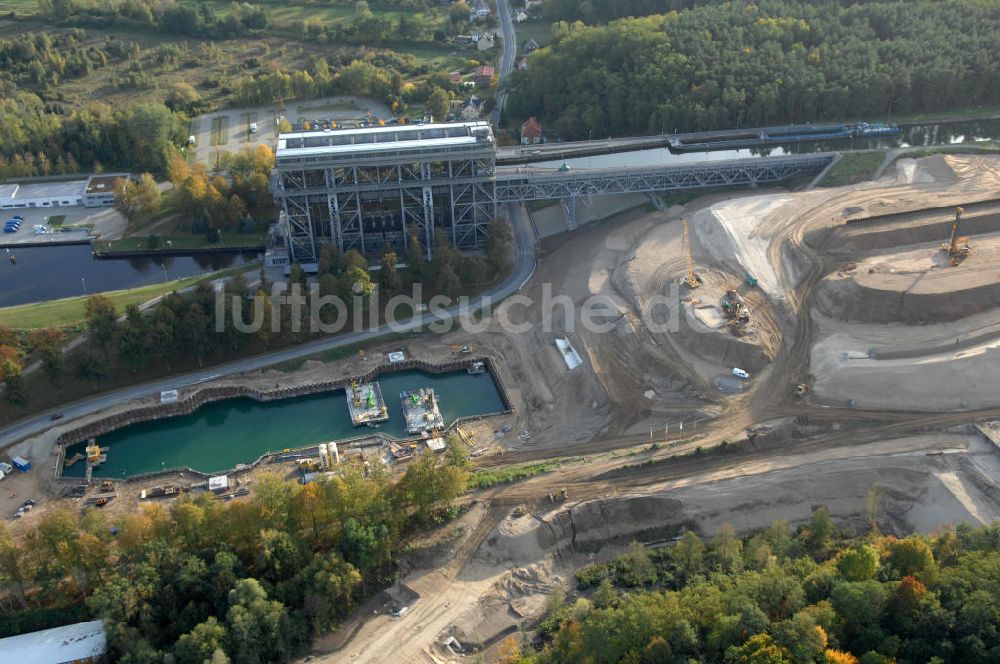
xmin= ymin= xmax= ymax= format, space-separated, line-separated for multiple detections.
xmin=63 ymin=371 xmax=504 ymax=478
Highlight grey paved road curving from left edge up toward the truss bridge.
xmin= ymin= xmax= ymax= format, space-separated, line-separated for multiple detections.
xmin=0 ymin=204 xmax=536 ymax=449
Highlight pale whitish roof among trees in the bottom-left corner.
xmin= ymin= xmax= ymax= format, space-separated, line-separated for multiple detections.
xmin=0 ymin=620 xmax=107 ymax=664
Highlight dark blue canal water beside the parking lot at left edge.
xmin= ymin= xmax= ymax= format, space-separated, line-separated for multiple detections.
xmin=0 ymin=244 xmax=259 ymax=307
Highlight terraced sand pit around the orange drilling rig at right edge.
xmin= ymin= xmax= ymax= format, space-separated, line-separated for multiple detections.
xmin=816 ymin=236 xmax=1000 ymax=324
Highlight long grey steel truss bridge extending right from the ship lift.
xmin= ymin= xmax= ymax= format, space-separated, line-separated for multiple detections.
xmin=496 ymin=152 xmax=834 ymax=230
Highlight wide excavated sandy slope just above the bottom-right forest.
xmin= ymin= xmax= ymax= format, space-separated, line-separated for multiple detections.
xmin=546 ymin=434 xmax=1000 ymax=552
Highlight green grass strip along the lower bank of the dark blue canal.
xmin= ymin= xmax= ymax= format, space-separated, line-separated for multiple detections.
xmin=0 ymin=265 xmax=255 ymax=330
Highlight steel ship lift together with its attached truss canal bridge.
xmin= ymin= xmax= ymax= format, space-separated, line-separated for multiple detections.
xmin=271 ymin=122 xmax=833 ymax=265
